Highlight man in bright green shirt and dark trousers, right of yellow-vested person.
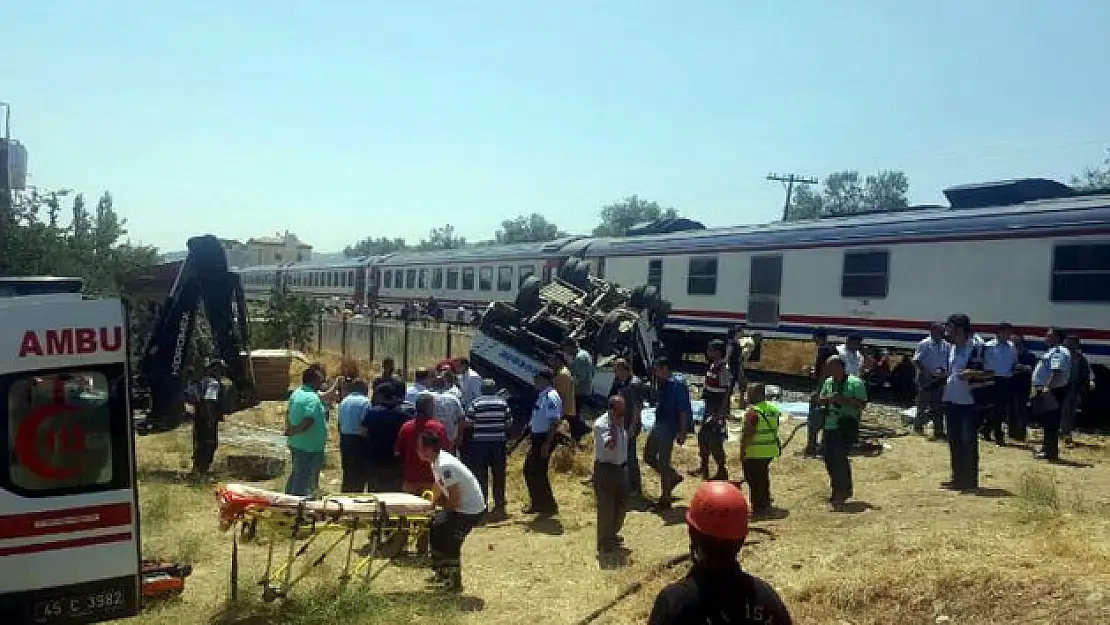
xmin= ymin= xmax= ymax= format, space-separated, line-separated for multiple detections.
xmin=817 ymin=356 xmax=867 ymax=507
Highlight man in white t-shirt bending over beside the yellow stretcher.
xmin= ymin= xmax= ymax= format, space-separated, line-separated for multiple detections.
xmin=416 ymin=432 xmax=485 ymax=593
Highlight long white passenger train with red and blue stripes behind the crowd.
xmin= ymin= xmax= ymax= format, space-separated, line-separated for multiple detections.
xmin=231 ymin=179 xmax=1110 ymax=377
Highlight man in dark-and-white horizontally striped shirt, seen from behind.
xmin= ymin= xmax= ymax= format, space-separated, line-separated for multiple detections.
xmin=462 ymin=379 xmax=509 ymax=520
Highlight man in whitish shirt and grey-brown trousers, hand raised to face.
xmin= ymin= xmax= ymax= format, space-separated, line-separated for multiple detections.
xmin=594 ymin=395 xmax=628 ymax=556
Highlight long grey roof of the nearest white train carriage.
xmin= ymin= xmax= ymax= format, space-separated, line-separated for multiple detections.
xmin=586 ymin=183 xmax=1110 ymax=256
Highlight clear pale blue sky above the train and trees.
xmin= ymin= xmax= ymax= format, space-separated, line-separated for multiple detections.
xmin=0 ymin=0 xmax=1110 ymax=251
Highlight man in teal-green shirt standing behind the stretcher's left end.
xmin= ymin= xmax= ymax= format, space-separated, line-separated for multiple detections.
xmin=285 ymin=367 xmax=327 ymax=497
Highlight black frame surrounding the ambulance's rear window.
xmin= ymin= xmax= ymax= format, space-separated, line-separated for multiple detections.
xmin=0 ymin=363 xmax=133 ymax=498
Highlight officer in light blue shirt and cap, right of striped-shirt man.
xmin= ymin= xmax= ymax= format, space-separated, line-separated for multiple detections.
xmin=524 ymin=369 xmax=563 ymax=516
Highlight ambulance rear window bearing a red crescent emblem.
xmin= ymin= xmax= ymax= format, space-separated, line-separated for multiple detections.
xmin=4 ymin=371 xmax=115 ymax=495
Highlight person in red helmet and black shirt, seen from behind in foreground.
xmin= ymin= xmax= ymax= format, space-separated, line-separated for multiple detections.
xmin=647 ymin=482 xmax=793 ymax=625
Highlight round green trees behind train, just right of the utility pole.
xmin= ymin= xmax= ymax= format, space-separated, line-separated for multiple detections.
xmin=787 ymin=170 xmax=909 ymax=221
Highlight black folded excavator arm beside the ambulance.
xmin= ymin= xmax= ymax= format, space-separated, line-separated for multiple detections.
xmin=139 ymin=234 xmax=259 ymax=427
